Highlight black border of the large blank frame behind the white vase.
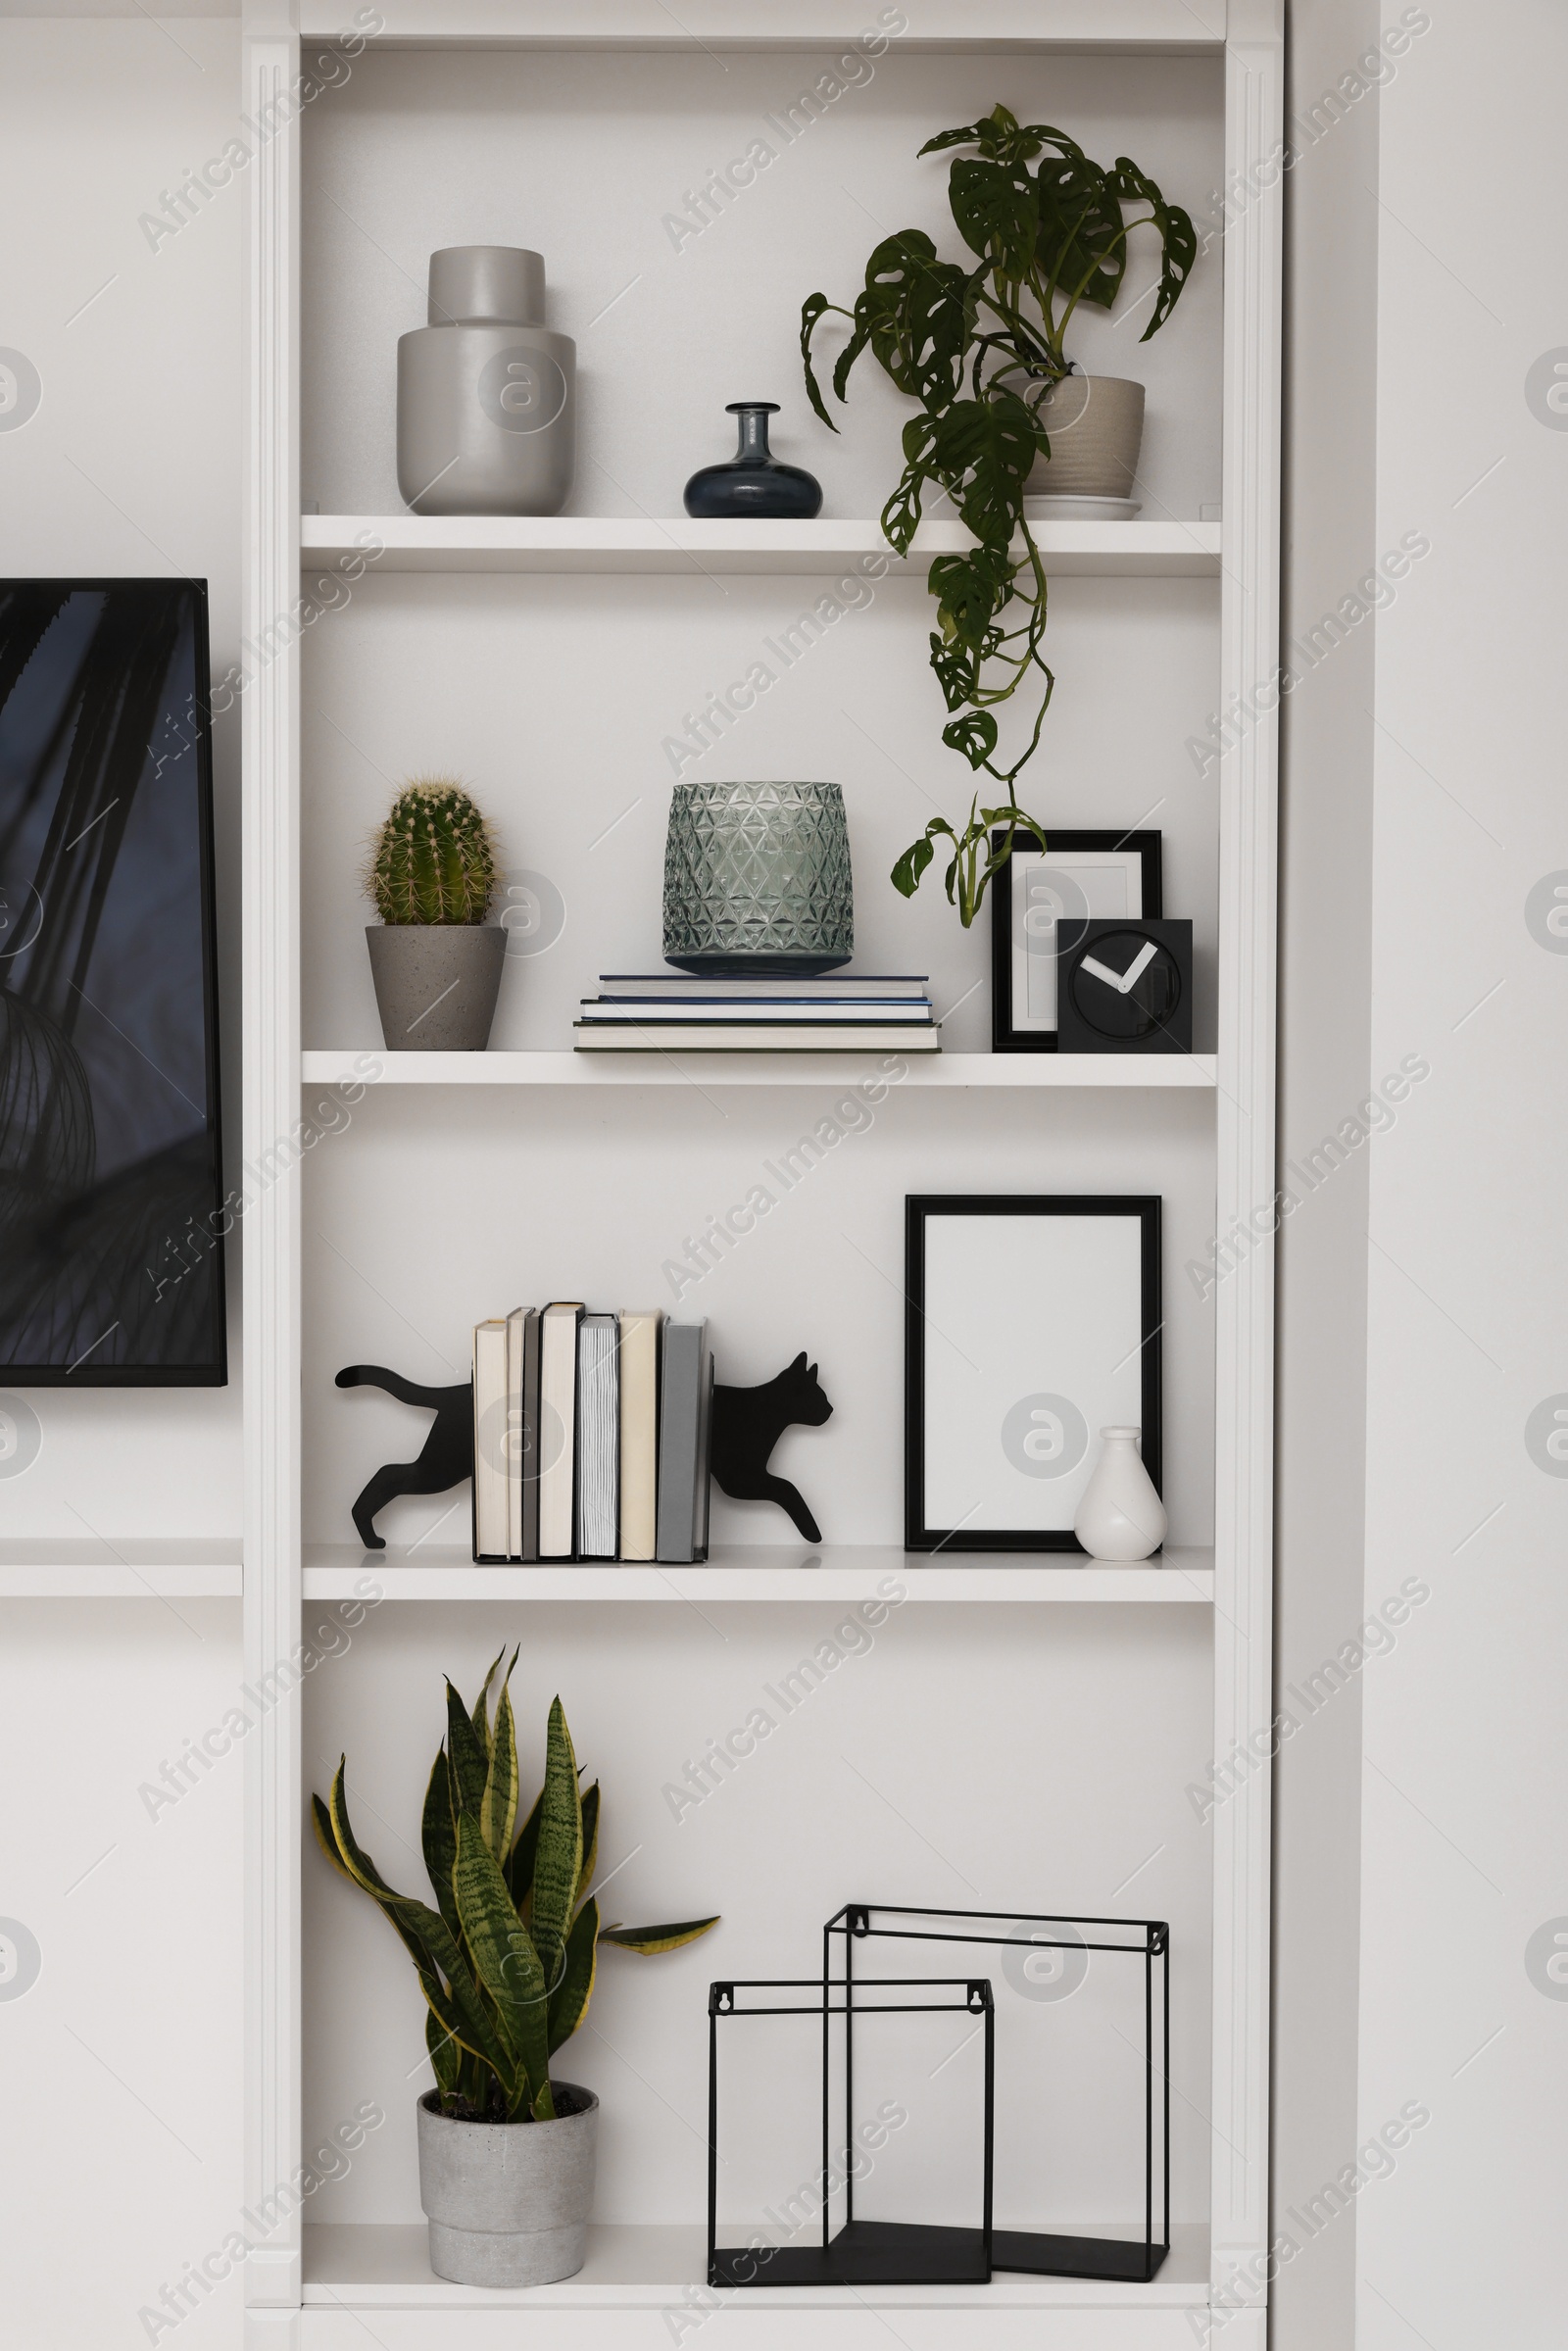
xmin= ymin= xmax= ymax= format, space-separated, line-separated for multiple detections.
xmin=903 ymin=1192 xmax=1161 ymax=1556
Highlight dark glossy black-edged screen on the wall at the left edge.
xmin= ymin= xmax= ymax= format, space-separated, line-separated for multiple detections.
xmin=0 ymin=578 xmax=228 ymax=1387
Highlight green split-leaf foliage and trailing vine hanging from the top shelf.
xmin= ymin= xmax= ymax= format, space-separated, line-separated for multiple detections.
xmin=800 ymin=106 xmax=1197 ymax=924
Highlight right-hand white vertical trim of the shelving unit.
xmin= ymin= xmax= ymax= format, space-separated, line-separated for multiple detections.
xmin=1212 ymin=0 xmax=1284 ymax=2313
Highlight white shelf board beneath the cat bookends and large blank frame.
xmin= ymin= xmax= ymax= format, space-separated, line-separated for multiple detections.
xmin=303 ymin=1543 xmax=1213 ymax=1606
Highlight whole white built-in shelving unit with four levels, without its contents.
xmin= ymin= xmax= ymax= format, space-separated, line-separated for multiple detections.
xmin=242 ymin=0 xmax=1281 ymax=2351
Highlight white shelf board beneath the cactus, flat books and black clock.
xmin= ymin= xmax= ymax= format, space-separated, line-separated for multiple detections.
xmin=299 ymin=1047 xmax=1215 ymax=1091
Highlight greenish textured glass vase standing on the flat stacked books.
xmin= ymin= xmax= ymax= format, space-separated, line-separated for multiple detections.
xmin=665 ymin=783 xmax=856 ymax=978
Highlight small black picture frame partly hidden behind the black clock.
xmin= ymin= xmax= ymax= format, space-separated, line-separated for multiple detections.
xmin=992 ymin=825 xmax=1163 ymax=1053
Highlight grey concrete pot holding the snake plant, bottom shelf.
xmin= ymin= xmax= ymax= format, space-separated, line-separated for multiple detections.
xmin=418 ymin=2081 xmax=600 ymax=2285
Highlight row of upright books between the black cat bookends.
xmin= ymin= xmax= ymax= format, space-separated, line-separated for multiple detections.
xmin=472 ymin=1302 xmax=712 ymax=1561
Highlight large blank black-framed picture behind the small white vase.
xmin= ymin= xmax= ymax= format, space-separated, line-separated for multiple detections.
xmin=903 ymin=1192 xmax=1161 ymax=1551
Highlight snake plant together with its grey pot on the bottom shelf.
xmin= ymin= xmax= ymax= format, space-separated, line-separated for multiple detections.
xmin=311 ymin=1650 xmax=717 ymax=2285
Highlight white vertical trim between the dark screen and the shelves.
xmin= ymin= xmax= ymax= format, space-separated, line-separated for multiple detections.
xmin=240 ymin=0 xmax=301 ymax=2323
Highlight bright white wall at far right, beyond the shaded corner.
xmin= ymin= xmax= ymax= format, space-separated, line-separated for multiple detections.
xmin=1356 ymin=0 xmax=1568 ymax=2351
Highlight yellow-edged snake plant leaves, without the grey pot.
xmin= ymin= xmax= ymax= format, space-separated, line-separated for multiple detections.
xmin=311 ymin=1650 xmax=717 ymax=2123
